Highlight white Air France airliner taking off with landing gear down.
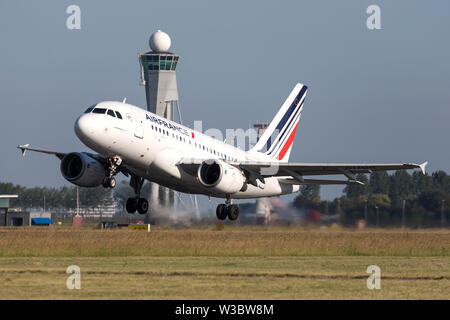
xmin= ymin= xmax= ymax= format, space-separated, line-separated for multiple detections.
xmin=18 ymin=83 xmax=427 ymax=220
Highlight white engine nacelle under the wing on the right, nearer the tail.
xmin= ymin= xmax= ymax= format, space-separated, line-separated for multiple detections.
xmin=197 ymin=159 xmax=246 ymax=194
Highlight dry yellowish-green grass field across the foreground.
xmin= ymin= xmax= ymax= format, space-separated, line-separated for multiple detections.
xmin=0 ymin=226 xmax=450 ymax=299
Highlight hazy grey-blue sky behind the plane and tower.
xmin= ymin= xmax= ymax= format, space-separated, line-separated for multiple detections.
xmin=0 ymin=0 xmax=450 ymax=204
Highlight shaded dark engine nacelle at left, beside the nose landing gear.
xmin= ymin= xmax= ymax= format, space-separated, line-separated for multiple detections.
xmin=61 ymin=152 xmax=106 ymax=187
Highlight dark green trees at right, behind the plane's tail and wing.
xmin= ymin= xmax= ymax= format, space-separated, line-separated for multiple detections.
xmin=293 ymin=170 xmax=450 ymax=227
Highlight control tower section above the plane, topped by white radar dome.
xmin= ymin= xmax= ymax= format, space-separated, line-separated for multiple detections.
xmin=138 ymin=30 xmax=181 ymax=122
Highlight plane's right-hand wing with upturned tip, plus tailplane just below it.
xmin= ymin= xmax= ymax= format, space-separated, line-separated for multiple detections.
xmin=179 ymin=159 xmax=428 ymax=185
